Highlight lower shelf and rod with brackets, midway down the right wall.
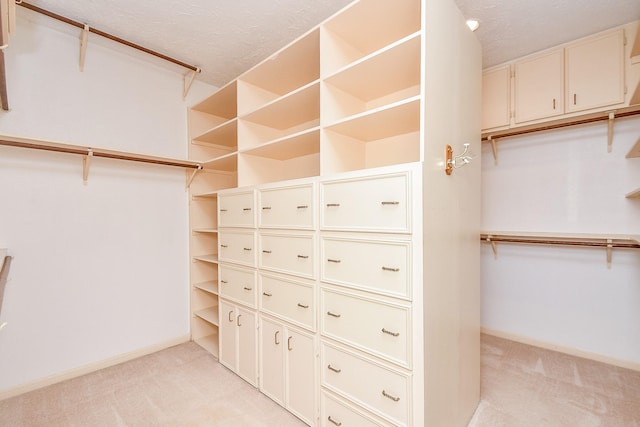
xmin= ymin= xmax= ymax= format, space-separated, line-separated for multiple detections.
xmin=480 ymin=232 xmax=640 ymax=268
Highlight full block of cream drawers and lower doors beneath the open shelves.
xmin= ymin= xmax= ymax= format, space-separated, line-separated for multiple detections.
xmin=218 ymin=165 xmax=422 ymax=427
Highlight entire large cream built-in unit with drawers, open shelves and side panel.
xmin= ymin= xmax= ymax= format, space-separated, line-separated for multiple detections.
xmin=189 ymin=0 xmax=481 ymax=427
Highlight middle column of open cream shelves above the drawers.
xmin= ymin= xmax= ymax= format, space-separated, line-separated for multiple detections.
xmin=238 ymin=29 xmax=320 ymax=186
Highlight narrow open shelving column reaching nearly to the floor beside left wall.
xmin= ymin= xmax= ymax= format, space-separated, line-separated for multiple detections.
xmin=189 ymin=82 xmax=238 ymax=357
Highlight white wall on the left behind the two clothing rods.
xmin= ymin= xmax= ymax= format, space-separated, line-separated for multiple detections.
xmin=0 ymin=8 xmax=214 ymax=394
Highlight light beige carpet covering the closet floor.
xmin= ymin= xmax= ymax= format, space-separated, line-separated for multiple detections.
xmin=0 ymin=335 xmax=640 ymax=427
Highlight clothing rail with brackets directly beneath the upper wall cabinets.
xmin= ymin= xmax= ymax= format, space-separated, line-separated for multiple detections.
xmin=481 ymin=104 xmax=640 ymax=164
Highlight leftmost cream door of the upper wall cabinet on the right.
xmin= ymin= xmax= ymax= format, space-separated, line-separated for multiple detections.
xmin=482 ymin=65 xmax=511 ymax=130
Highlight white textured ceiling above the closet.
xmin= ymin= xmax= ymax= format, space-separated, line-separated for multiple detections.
xmin=19 ymin=0 xmax=640 ymax=86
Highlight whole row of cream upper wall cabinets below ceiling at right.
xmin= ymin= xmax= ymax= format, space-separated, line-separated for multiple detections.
xmin=482 ymin=23 xmax=637 ymax=131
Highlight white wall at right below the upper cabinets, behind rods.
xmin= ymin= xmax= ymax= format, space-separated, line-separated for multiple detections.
xmin=482 ymin=117 xmax=640 ymax=366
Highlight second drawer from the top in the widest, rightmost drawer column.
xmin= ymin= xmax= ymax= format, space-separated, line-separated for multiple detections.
xmin=320 ymin=237 xmax=411 ymax=299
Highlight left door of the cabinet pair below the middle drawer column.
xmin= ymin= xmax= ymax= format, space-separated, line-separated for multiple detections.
xmin=260 ymin=317 xmax=287 ymax=406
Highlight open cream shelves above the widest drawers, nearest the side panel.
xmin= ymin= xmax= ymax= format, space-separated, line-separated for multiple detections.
xmin=320 ymin=0 xmax=421 ymax=175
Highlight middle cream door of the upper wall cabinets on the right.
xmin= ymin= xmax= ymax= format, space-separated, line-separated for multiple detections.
xmin=515 ymin=49 xmax=564 ymax=123
